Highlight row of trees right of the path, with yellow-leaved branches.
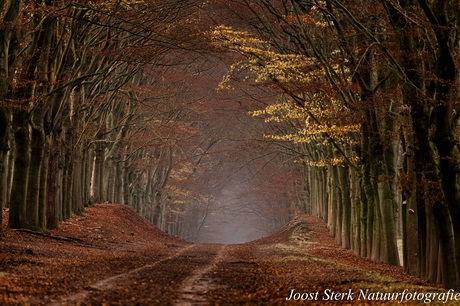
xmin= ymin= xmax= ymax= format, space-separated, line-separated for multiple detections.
xmin=210 ymin=0 xmax=460 ymax=289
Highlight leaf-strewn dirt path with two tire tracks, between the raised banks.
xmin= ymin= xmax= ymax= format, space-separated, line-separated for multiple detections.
xmin=50 ymin=241 xmax=442 ymax=306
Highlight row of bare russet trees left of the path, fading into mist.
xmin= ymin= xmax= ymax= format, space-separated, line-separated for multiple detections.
xmin=0 ymin=0 xmax=300 ymax=240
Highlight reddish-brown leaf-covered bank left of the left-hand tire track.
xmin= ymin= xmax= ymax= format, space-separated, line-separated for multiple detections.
xmin=0 ymin=204 xmax=186 ymax=305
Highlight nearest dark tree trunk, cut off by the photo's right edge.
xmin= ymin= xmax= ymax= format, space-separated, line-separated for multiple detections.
xmin=430 ymin=1 xmax=460 ymax=289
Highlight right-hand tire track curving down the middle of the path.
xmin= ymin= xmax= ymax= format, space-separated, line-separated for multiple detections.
xmin=175 ymin=245 xmax=227 ymax=306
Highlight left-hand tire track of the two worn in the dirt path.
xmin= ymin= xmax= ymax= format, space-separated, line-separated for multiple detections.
xmin=48 ymin=244 xmax=196 ymax=306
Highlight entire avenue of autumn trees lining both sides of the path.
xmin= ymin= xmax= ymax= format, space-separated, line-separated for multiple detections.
xmin=0 ymin=0 xmax=460 ymax=289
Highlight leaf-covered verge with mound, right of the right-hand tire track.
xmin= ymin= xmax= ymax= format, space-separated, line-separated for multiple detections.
xmin=209 ymin=216 xmax=450 ymax=305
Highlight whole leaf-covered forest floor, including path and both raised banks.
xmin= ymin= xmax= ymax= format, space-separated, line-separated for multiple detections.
xmin=0 ymin=204 xmax=455 ymax=305
